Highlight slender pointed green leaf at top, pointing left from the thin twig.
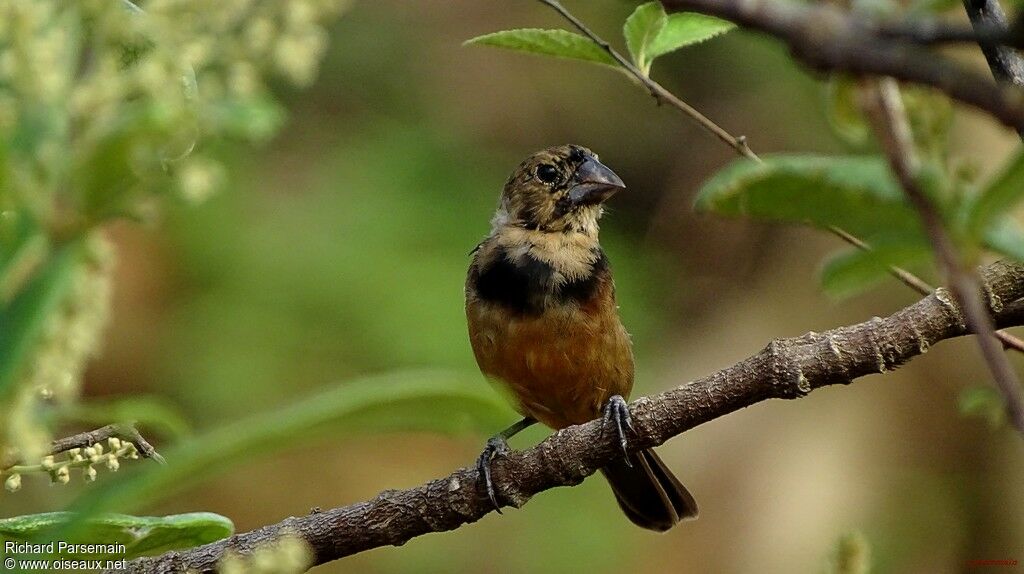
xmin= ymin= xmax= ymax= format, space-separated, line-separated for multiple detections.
xmin=463 ymin=28 xmax=618 ymax=68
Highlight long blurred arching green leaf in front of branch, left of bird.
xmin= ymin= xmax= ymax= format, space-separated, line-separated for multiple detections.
xmin=60 ymin=370 xmax=514 ymax=532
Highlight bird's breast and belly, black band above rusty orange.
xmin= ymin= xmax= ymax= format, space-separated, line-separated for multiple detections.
xmin=466 ymin=240 xmax=633 ymax=428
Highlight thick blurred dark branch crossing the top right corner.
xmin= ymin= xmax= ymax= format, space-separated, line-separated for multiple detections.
xmin=663 ymin=0 xmax=1024 ymax=130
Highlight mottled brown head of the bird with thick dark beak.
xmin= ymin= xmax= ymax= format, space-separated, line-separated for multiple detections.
xmin=493 ymin=145 xmax=626 ymax=235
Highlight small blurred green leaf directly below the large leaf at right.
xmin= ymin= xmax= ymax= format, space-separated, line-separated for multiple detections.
xmin=821 ymin=242 xmax=931 ymax=299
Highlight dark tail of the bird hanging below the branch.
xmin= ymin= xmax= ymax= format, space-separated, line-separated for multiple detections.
xmin=601 ymin=449 xmax=697 ymax=532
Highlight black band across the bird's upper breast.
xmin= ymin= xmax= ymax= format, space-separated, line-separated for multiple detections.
xmin=470 ymin=248 xmax=608 ymax=315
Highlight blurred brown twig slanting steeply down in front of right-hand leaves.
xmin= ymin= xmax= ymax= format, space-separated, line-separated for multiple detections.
xmin=868 ymin=78 xmax=1024 ymax=434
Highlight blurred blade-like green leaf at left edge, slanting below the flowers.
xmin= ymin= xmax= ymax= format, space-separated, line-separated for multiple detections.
xmin=0 ymin=240 xmax=86 ymax=400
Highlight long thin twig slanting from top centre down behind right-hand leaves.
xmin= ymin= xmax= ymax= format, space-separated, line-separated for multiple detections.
xmin=540 ymin=0 xmax=1024 ymax=353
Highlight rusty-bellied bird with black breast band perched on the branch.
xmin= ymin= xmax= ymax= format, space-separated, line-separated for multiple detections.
xmin=465 ymin=144 xmax=697 ymax=532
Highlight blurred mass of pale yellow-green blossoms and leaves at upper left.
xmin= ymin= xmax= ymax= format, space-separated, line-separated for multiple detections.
xmin=0 ymin=0 xmax=348 ymax=457
